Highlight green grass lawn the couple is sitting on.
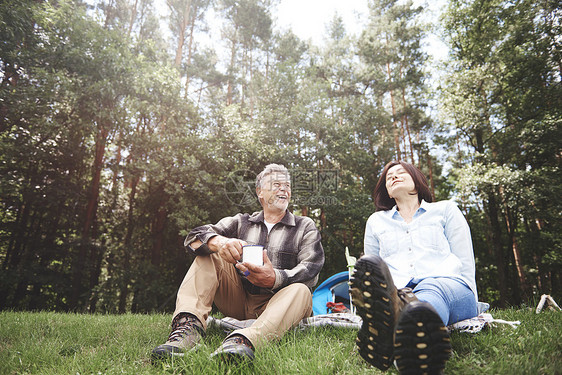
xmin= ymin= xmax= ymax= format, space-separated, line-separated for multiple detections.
xmin=0 ymin=309 xmax=562 ymax=375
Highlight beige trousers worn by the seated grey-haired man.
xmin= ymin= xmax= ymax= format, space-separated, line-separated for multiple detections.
xmin=174 ymin=254 xmax=312 ymax=348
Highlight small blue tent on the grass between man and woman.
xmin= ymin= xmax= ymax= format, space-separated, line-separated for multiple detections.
xmin=312 ymin=271 xmax=351 ymax=315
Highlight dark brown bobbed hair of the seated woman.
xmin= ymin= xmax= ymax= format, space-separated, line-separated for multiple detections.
xmin=373 ymin=161 xmax=433 ymax=211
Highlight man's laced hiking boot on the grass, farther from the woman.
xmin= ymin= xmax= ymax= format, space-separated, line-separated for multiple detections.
xmin=152 ymin=313 xmax=205 ymax=362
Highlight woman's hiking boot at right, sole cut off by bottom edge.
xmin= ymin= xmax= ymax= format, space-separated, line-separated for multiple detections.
xmin=394 ymin=302 xmax=451 ymax=374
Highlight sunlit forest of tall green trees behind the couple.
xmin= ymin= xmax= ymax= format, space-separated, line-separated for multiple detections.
xmin=0 ymin=0 xmax=562 ymax=313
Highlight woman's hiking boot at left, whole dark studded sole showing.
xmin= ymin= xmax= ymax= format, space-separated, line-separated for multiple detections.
xmin=350 ymin=255 xmax=417 ymax=371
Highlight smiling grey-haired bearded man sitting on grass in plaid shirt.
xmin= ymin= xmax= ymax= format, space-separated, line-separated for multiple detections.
xmin=152 ymin=164 xmax=324 ymax=362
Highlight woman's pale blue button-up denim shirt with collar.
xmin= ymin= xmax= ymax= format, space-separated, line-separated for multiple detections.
xmin=364 ymin=201 xmax=478 ymax=301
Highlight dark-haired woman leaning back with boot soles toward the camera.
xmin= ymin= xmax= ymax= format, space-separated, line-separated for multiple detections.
xmin=351 ymin=161 xmax=477 ymax=373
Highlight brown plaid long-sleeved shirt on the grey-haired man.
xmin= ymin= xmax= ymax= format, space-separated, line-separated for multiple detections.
xmin=185 ymin=211 xmax=324 ymax=294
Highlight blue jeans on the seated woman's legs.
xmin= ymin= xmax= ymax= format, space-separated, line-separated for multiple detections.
xmin=407 ymin=277 xmax=478 ymax=326
